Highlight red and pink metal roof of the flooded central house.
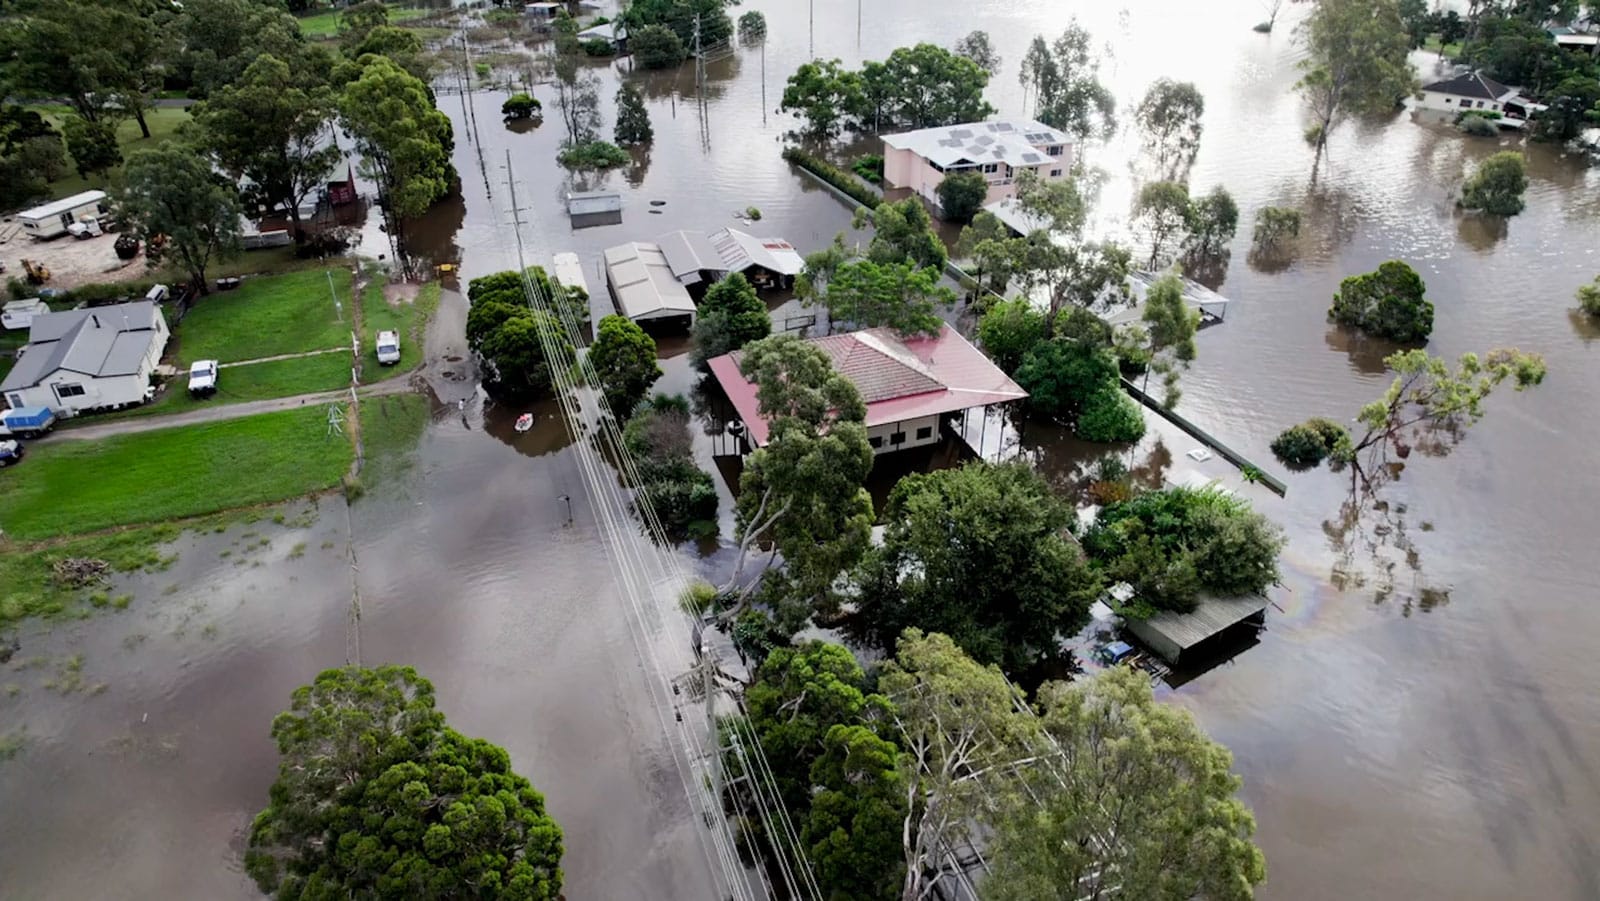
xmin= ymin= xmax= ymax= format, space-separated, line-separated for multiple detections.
xmin=709 ymin=325 xmax=1027 ymax=446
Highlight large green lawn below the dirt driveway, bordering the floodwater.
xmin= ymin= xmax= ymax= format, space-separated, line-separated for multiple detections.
xmin=0 ymin=405 xmax=352 ymax=541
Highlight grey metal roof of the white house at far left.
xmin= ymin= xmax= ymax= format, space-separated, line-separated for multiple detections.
xmin=0 ymin=301 xmax=160 ymax=390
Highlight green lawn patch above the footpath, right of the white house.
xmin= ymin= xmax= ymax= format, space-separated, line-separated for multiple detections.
xmin=176 ymin=269 xmax=350 ymax=363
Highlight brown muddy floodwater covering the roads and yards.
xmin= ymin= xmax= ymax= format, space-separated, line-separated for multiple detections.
xmin=0 ymin=0 xmax=1600 ymax=899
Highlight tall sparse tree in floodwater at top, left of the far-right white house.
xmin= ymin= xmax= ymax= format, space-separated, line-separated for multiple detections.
xmin=1294 ymin=0 xmax=1416 ymax=174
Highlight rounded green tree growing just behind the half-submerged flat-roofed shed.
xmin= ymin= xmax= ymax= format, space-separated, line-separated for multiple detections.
xmin=1083 ymin=488 xmax=1283 ymax=611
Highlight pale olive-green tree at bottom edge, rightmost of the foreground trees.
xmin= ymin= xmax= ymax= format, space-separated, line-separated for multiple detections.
xmin=984 ymin=666 xmax=1267 ymax=901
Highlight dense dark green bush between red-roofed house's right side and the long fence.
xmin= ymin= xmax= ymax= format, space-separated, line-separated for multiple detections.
xmin=1016 ymin=338 xmax=1144 ymax=442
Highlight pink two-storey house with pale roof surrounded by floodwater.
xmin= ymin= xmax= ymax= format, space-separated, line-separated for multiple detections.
xmin=883 ymin=118 xmax=1072 ymax=211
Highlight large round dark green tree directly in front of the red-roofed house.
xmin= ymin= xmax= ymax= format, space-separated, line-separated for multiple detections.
xmin=858 ymin=463 xmax=1101 ymax=671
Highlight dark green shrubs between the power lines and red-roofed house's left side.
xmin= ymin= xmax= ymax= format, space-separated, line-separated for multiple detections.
xmin=620 ymin=403 xmax=717 ymax=539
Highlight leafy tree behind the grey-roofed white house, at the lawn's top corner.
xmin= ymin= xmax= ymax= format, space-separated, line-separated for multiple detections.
xmin=117 ymin=142 xmax=240 ymax=294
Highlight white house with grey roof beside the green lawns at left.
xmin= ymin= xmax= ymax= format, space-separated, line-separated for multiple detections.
xmin=0 ymin=301 xmax=171 ymax=414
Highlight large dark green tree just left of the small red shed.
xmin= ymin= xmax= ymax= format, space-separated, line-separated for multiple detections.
xmin=192 ymin=53 xmax=342 ymax=232
